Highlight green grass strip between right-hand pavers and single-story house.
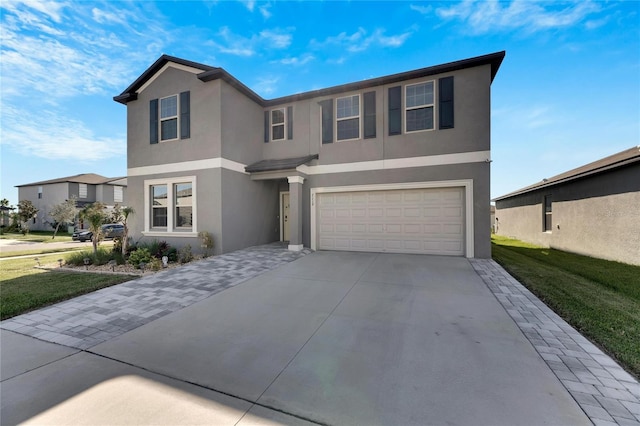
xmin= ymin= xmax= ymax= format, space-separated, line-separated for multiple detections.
xmin=492 ymin=236 xmax=640 ymax=377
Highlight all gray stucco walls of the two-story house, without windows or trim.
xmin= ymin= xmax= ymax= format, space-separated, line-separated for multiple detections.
xmin=127 ymin=60 xmax=491 ymax=257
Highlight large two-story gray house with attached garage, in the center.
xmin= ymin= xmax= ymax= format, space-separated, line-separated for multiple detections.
xmin=114 ymin=52 xmax=505 ymax=257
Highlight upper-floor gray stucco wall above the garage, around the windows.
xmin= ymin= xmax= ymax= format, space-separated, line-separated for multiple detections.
xmin=259 ymin=65 xmax=491 ymax=164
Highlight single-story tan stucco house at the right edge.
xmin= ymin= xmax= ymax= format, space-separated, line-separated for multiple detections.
xmin=495 ymin=147 xmax=640 ymax=265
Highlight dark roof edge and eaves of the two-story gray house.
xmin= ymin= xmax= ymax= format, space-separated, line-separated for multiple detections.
xmin=113 ymin=50 xmax=506 ymax=106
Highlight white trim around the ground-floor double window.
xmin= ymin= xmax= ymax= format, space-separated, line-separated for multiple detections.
xmin=142 ymin=176 xmax=198 ymax=237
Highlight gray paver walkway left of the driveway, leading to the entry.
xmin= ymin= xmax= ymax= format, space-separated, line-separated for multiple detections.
xmin=0 ymin=243 xmax=311 ymax=349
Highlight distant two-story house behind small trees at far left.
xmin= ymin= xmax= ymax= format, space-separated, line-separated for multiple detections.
xmin=16 ymin=173 xmax=127 ymax=231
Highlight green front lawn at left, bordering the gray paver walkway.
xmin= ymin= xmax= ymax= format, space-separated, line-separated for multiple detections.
xmin=0 ymin=254 xmax=134 ymax=320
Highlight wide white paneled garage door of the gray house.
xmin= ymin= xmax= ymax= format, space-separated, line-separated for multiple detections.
xmin=317 ymin=188 xmax=464 ymax=256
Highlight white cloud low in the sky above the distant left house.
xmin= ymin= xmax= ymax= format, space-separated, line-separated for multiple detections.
xmin=1 ymin=107 xmax=126 ymax=161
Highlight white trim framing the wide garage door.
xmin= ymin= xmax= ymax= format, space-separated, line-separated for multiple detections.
xmin=310 ymin=179 xmax=475 ymax=258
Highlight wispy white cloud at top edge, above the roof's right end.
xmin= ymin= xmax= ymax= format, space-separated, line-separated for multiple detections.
xmin=436 ymin=0 xmax=600 ymax=33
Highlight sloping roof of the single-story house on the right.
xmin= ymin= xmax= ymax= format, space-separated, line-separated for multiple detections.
xmin=493 ymin=145 xmax=640 ymax=201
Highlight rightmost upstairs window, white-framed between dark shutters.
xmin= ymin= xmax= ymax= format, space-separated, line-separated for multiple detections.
xmin=405 ymin=81 xmax=434 ymax=132
